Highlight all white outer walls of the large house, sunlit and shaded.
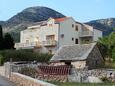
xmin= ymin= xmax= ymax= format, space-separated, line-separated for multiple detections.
xmin=20 ymin=18 xmax=102 ymax=51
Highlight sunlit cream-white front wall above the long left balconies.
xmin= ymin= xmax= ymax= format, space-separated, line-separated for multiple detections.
xmin=20 ymin=20 xmax=59 ymax=43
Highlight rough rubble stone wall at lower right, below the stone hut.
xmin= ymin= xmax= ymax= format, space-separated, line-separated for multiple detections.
xmin=68 ymin=68 xmax=115 ymax=83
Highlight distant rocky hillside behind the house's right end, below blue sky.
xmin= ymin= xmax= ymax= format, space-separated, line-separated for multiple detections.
xmin=86 ymin=18 xmax=115 ymax=35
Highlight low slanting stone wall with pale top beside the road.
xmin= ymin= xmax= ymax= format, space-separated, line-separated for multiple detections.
xmin=10 ymin=72 xmax=56 ymax=86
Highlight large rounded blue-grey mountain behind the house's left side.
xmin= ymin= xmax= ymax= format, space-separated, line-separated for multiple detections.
xmin=0 ymin=6 xmax=65 ymax=41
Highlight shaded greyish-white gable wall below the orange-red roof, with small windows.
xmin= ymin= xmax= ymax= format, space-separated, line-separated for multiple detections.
xmin=59 ymin=18 xmax=80 ymax=46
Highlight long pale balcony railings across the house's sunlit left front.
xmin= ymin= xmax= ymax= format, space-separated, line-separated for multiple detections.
xmin=14 ymin=40 xmax=57 ymax=49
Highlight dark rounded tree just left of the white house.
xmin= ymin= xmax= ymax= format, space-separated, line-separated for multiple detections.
xmin=3 ymin=33 xmax=14 ymax=49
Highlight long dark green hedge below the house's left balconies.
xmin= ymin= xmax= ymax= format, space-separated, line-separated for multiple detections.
xmin=0 ymin=50 xmax=52 ymax=62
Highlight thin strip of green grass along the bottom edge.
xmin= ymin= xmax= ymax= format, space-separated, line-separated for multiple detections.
xmin=50 ymin=82 xmax=115 ymax=86
